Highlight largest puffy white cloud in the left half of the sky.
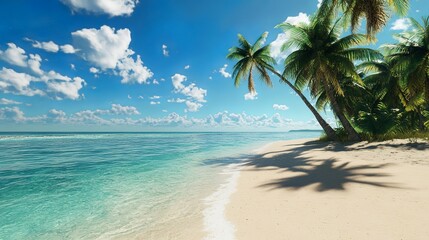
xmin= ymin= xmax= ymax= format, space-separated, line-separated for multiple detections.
xmin=72 ymin=25 xmax=153 ymax=84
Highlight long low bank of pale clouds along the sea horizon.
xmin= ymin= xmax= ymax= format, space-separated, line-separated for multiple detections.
xmin=0 ymin=104 xmax=320 ymax=130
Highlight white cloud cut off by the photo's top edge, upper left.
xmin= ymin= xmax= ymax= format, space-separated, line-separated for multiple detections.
xmin=62 ymin=0 xmax=139 ymax=17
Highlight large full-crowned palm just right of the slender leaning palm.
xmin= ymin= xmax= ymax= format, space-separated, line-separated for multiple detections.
xmin=278 ymin=18 xmax=381 ymax=141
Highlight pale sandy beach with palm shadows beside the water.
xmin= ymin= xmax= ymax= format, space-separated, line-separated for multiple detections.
xmin=226 ymin=139 xmax=429 ymax=240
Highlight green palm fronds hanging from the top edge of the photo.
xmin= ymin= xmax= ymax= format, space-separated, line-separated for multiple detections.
xmin=319 ymin=0 xmax=409 ymax=36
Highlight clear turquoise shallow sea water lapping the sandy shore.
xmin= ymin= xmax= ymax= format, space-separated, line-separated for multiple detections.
xmin=0 ymin=132 xmax=320 ymax=239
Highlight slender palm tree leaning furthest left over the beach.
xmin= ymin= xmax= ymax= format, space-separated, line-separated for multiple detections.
xmin=227 ymin=32 xmax=337 ymax=140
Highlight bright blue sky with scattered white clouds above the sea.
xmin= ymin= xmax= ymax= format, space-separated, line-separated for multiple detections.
xmin=0 ymin=0 xmax=429 ymax=131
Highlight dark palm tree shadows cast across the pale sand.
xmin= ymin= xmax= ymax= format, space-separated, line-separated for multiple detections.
xmin=204 ymin=141 xmax=402 ymax=192
